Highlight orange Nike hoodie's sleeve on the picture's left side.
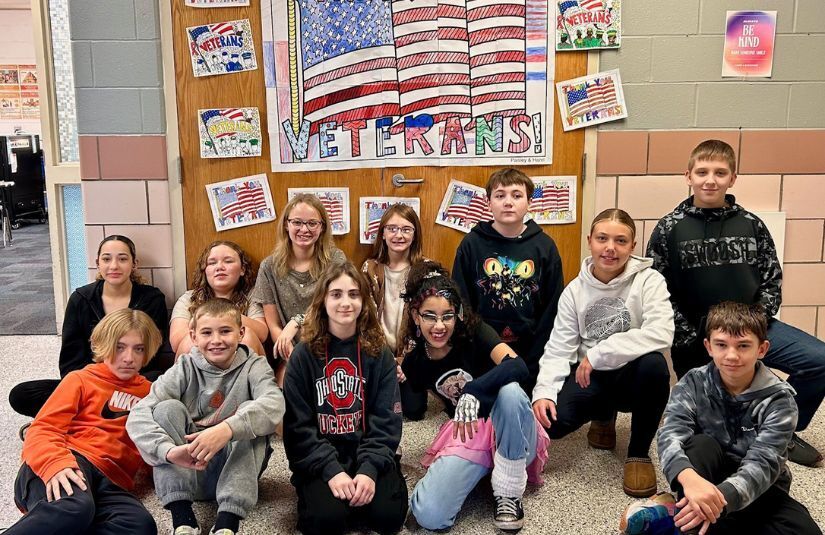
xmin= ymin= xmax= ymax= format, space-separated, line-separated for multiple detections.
xmin=23 ymin=372 xmax=83 ymax=483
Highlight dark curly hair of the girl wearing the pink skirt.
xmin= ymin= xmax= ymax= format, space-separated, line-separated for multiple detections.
xmin=400 ymin=260 xmax=479 ymax=348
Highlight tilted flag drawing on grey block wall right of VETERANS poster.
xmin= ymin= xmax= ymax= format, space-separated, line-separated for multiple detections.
xmin=556 ymin=69 xmax=627 ymax=132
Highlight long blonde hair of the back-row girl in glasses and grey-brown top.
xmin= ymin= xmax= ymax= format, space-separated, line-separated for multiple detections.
xmin=272 ymin=193 xmax=334 ymax=279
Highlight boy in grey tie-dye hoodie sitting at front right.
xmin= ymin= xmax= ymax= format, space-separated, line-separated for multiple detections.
xmin=658 ymin=301 xmax=822 ymax=535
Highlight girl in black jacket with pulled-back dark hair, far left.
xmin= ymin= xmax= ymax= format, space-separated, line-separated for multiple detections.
xmin=9 ymin=234 xmax=171 ymax=420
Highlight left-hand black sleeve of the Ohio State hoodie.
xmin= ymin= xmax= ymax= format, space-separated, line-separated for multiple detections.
xmin=284 ymin=343 xmax=346 ymax=481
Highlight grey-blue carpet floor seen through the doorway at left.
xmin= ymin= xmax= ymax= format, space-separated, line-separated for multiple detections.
xmin=0 ymin=223 xmax=57 ymax=335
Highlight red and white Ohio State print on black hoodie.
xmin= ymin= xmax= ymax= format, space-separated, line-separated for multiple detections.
xmin=315 ymin=357 xmax=364 ymax=435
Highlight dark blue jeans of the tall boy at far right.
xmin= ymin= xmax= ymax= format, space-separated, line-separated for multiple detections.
xmin=762 ymin=320 xmax=825 ymax=431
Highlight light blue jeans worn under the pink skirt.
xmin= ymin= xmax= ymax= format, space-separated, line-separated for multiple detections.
xmin=410 ymin=383 xmax=537 ymax=530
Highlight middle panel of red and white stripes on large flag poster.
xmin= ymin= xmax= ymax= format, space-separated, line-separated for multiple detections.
xmin=392 ymin=0 xmax=471 ymax=122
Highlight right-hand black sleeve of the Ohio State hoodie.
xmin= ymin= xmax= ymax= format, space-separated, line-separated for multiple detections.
xmin=357 ymin=347 xmax=401 ymax=481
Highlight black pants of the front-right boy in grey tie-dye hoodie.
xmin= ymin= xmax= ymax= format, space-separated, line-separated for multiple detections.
xmin=671 ymin=435 xmax=822 ymax=535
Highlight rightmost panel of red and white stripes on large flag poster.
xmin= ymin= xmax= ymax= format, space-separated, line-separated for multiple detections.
xmin=467 ymin=0 xmax=527 ymax=117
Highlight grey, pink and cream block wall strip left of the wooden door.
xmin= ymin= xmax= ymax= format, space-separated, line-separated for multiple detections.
xmin=69 ymin=0 xmax=176 ymax=308
